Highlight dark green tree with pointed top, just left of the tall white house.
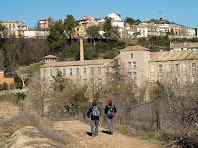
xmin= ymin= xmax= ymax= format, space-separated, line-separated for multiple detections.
xmin=103 ymin=17 xmax=120 ymax=39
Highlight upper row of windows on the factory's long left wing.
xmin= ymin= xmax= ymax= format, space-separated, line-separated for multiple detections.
xmin=44 ymin=67 xmax=109 ymax=76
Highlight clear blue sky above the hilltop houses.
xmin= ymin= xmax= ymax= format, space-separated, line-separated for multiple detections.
xmin=0 ymin=0 xmax=198 ymax=28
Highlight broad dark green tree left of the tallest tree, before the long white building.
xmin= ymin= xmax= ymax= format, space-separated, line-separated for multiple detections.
xmin=47 ymin=20 xmax=66 ymax=53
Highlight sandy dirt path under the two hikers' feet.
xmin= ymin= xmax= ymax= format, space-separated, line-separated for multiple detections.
xmin=54 ymin=120 xmax=163 ymax=148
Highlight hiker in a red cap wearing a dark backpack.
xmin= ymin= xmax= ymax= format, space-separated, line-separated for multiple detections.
xmin=105 ymin=100 xmax=117 ymax=135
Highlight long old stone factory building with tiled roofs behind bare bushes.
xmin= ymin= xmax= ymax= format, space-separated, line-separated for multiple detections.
xmin=40 ymin=46 xmax=198 ymax=100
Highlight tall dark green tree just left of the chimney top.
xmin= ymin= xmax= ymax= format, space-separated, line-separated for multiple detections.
xmin=63 ymin=15 xmax=78 ymax=42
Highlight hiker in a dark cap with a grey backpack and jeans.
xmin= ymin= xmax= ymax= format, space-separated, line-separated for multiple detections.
xmin=87 ymin=102 xmax=101 ymax=137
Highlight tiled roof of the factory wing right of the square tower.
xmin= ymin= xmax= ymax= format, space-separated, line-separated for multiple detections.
xmin=149 ymin=50 xmax=198 ymax=61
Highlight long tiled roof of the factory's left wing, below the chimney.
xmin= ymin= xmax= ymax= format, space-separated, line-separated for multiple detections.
xmin=41 ymin=59 xmax=111 ymax=68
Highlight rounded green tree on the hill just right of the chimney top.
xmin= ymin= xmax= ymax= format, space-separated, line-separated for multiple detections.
xmin=86 ymin=25 xmax=100 ymax=44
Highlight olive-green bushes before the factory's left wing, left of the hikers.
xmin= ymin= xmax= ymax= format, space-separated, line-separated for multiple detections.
xmin=52 ymin=71 xmax=88 ymax=111
